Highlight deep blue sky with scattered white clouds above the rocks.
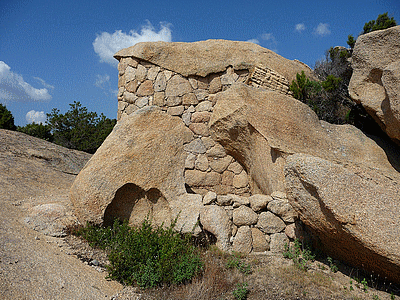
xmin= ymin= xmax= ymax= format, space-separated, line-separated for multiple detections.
xmin=0 ymin=0 xmax=400 ymax=126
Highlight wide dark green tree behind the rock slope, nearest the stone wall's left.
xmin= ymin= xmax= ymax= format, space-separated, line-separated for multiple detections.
xmin=47 ymin=101 xmax=116 ymax=153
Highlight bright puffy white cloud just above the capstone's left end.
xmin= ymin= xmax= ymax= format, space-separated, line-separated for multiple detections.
xmin=93 ymin=22 xmax=172 ymax=66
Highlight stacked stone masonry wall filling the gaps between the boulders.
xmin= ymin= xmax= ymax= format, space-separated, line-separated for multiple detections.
xmin=118 ymin=57 xmax=295 ymax=253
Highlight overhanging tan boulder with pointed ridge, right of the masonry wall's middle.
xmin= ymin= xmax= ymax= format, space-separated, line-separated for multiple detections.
xmin=209 ymin=84 xmax=395 ymax=195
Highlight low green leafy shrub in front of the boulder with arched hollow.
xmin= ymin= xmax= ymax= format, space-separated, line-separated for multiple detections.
xmin=77 ymin=219 xmax=203 ymax=288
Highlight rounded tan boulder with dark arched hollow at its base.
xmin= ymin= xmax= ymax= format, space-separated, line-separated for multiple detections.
xmin=70 ymin=106 xmax=202 ymax=233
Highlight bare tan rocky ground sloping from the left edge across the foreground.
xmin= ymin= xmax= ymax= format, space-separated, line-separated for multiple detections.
xmin=0 ymin=130 xmax=400 ymax=300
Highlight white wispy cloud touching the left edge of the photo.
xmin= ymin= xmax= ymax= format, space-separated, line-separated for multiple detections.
xmin=0 ymin=61 xmax=54 ymax=102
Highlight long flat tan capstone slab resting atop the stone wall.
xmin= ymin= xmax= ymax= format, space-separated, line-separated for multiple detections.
xmin=114 ymin=40 xmax=313 ymax=83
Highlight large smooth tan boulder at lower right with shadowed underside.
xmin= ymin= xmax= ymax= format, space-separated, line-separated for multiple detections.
xmin=285 ymin=154 xmax=400 ymax=283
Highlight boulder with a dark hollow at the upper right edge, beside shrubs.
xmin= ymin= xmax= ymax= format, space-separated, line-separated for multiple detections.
xmin=349 ymin=26 xmax=400 ymax=143
